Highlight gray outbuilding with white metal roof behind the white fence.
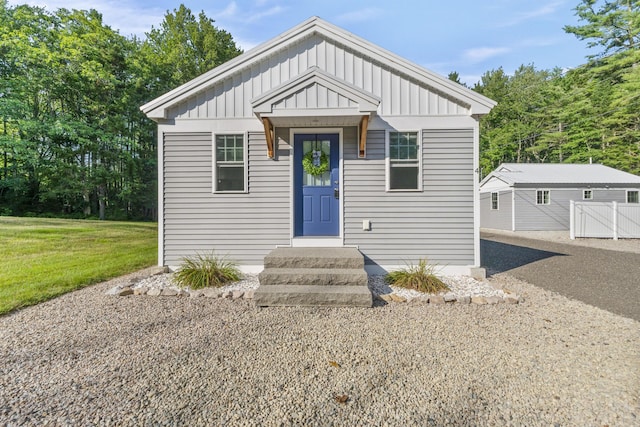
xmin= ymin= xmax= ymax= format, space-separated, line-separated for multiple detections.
xmin=480 ymin=163 xmax=640 ymax=231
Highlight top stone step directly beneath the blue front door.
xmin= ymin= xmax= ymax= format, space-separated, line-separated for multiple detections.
xmin=264 ymin=248 xmax=364 ymax=268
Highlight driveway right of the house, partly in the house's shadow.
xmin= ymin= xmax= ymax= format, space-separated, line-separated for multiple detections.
xmin=481 ymin=230 xmax=640 ymax=321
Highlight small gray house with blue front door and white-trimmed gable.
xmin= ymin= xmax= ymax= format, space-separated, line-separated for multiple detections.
xmin=141 ymin=17 xmax=495 ymax=286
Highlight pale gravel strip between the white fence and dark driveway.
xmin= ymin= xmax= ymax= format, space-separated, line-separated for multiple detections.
xmin=481 ymin=228 xmax=640 ymax=254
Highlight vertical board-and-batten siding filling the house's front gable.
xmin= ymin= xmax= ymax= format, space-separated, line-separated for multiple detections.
xmin=168 ymin=34 xmax=469 ymax=119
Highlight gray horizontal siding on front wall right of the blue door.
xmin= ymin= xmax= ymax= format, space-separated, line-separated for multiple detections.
xmin=344 ymin=129 xmax=474 ymax=265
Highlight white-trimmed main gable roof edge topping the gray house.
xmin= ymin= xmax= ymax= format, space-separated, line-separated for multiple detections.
xmin=140 ymin=17 xmax=496 ymax=119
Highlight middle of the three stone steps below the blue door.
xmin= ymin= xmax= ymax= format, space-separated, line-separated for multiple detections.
xmin=258 ymin=267 xmax=367 ymax=288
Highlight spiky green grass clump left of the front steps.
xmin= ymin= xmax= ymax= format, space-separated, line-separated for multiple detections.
xmin=174 ymin=253 xmax=242 ymax=289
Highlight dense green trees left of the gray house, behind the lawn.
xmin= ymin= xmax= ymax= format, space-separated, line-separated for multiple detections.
xmin=0 ymin=0 xmax=241 ymax=219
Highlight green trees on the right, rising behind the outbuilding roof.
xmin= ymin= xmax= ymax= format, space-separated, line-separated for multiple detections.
xmin=468 ymin=0 xmax=640 ymax=175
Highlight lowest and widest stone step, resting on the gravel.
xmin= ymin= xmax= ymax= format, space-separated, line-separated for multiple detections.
xmin=253 ymin=285 xmax=373 ymax=307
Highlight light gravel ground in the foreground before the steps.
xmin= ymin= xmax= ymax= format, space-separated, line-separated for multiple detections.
xmin=0 ymin=272 xmax=640 ymax=426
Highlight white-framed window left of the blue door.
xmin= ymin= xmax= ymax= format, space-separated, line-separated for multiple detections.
xmin=214 ymin=135 xmax=246 ymax=192
